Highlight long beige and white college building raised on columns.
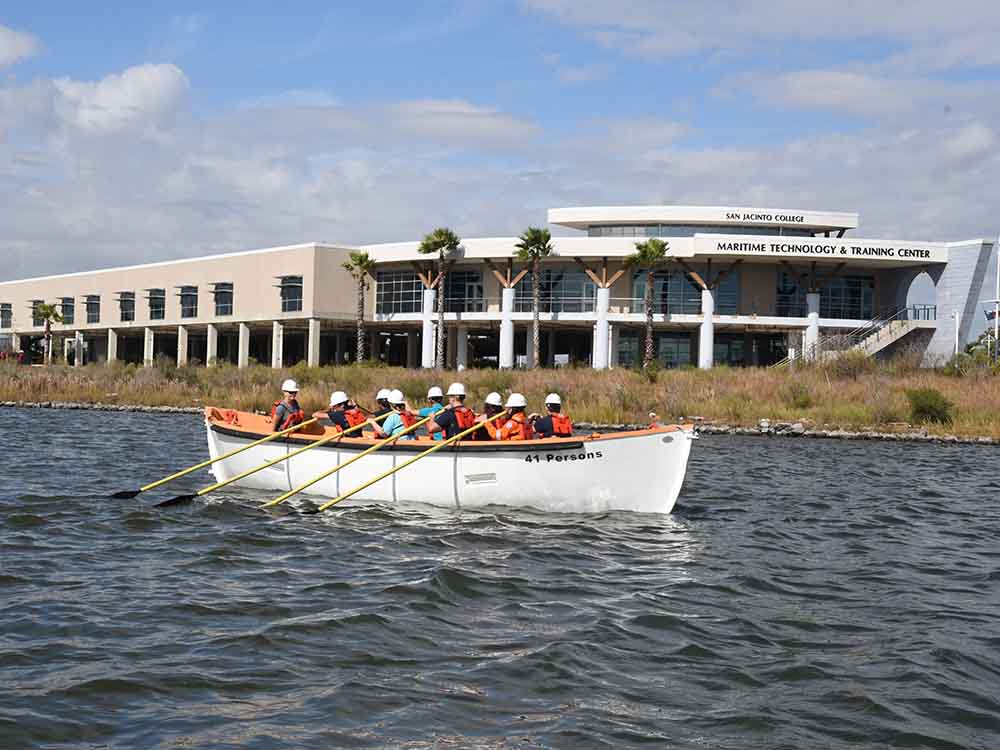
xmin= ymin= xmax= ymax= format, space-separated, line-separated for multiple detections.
xmin=0 ymin=206 xmax=993 ymax=369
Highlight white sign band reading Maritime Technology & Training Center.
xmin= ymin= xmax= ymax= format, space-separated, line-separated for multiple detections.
xmin=695 ymin=235 xmax=948 ymax=263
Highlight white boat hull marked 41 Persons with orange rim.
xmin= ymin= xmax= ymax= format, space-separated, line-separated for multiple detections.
xmin=206 ymin=419 xmax=693 ymax=513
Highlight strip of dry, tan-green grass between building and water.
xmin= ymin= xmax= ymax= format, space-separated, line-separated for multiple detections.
xmin=0 ymin=361 xmax=1000 ymax=438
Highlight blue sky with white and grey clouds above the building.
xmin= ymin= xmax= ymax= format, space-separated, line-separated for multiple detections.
xmin=0 ymin=0 xmax=1000 ymax=332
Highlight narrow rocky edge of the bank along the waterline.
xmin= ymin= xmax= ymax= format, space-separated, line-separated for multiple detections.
xmin=0 ymin=401 xmax=1000 ymax=445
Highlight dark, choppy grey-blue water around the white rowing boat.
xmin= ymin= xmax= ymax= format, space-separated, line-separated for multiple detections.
xmin=0 ymin=410 xmax=1000 ymax=750
